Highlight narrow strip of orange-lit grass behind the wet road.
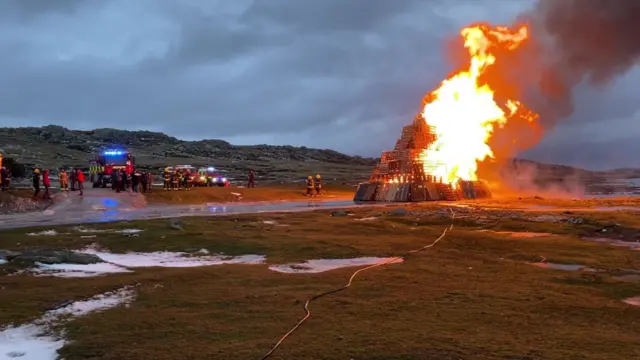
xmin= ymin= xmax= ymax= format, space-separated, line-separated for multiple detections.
xmin=145 ymin=184 xmax=356 ymax=204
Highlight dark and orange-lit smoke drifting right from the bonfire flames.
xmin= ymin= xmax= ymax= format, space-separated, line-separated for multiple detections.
xmin=480 ymin=0 xmax=640 ymax=196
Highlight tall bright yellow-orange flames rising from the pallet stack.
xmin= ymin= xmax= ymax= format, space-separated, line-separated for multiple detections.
xmin=420 ymin=25 xmax=537 ymax=185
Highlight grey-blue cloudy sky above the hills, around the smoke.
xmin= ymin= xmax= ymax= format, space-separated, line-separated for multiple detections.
xmin=0 ymin=0 xmax=640 ymax=168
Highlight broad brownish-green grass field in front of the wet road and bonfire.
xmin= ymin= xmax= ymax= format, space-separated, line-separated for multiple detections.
xmin=0 ymin=205 xmax=640 ymax=360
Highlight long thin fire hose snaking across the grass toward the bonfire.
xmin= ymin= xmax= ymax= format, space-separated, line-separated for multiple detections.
xmin=260 ymin=208 xmax=456 ymax=360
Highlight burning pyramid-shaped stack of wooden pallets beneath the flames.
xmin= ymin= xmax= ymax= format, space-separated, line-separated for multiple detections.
xmin=354 ymin=114 xmax=491 ymax=202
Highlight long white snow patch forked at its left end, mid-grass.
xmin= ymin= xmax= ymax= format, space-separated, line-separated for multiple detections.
xmin=32 ymin=247 xmax=265 ymax=277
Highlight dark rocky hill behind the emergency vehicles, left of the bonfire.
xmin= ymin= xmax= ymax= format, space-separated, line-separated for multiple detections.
xmin=0 ymin=125 xmax=376 ymax=182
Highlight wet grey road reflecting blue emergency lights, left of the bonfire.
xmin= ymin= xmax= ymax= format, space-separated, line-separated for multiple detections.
xmin=0 ymin=189 xmax=375 ymax=229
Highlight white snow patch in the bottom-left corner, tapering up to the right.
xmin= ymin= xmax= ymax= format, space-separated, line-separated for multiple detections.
xmin=0 ymin=287 xmax=135 ymax=360
